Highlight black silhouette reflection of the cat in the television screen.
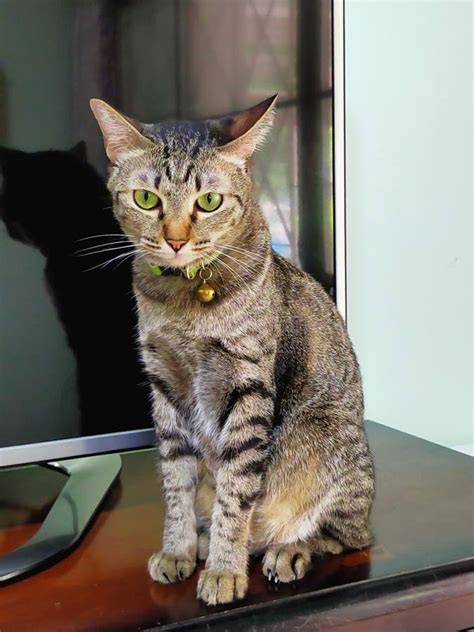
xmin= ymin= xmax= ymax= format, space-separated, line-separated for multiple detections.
xmin=0 ymin=142 xmax=149 ymax=435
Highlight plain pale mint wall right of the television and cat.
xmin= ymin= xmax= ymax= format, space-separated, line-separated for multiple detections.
xmin=346 ymin=0 xmax=474 ymax=446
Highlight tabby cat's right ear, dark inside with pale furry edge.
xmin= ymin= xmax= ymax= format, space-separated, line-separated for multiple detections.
xmin=218 ymin=94 xmax=278 ymax=165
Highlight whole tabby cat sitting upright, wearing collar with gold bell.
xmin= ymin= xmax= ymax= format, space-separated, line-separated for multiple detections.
xmin=91 ymin=97 xmax=374 ymax=604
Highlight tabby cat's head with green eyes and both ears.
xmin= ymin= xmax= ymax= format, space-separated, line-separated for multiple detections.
xmin=91 ymin=96 xmax=276 ymax=267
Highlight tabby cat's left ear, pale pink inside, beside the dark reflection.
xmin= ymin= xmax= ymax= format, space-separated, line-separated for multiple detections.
xmin=90 ymin=99 xmax=153 ymax=163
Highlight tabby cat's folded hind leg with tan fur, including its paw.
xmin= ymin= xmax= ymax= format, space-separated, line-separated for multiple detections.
xmin=252 ymin=409 xmax=374 ymax=582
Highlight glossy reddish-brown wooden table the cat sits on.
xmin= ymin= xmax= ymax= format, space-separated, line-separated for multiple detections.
xmin=0 ymin=422 xmax=474 ymax=632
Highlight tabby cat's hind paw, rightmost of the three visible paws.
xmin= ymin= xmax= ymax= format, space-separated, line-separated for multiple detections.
xmin=263 ymin=544 xmax=311 ymax=584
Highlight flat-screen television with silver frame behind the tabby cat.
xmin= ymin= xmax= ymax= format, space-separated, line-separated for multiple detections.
xmin=0 ymin=0 xmax=345 ymax=584
